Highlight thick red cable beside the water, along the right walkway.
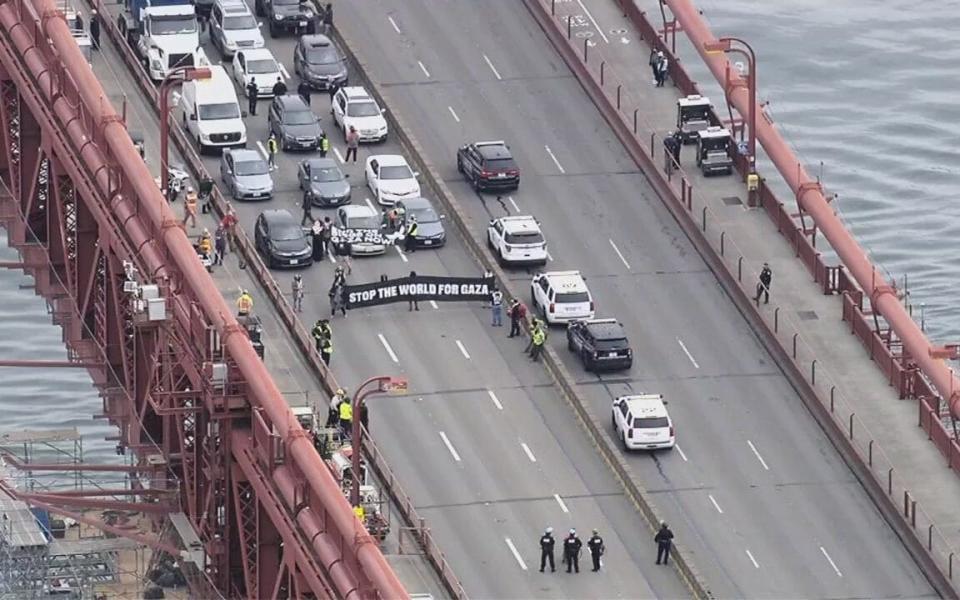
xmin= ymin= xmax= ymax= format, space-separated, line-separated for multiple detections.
xmin=663 ymin=0 xmax=960 ymax=418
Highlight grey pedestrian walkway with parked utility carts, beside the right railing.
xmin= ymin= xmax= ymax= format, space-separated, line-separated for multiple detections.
xmin=539 ymin=0 xmax=960 ymax=572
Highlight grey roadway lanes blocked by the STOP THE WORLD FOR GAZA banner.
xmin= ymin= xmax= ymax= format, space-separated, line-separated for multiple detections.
xmin=88 ymin=2 xmax=689 ymax=598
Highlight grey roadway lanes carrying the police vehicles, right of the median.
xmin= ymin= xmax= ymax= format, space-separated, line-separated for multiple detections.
xmin=324 ymin=0 xmax=932 ymax=598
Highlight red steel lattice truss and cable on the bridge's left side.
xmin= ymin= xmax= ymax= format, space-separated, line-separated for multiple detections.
xmin=0 ymin=0 xmax=407 ymax=599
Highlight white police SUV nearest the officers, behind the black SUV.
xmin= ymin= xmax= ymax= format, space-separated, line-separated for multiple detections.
xmin=610 ymin=394 xmax=677 ymax=450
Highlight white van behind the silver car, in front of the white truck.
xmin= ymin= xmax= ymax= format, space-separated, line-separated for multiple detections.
xmin=179 ymin=65 xmax=247 ymax=154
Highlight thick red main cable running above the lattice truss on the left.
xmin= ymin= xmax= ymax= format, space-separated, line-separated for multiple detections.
xmin=0 ymin=0 xmax=407 ymax=598
